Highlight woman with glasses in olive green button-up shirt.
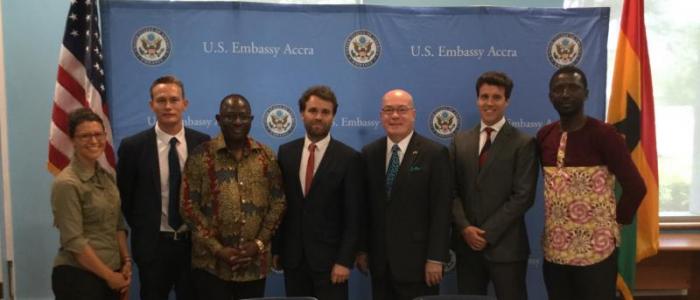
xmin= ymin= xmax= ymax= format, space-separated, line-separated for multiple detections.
xmin=51 ymin=108 xmax=131 ymax=300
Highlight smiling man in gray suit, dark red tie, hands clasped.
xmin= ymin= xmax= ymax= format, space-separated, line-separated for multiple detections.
xmin=450 ymin=72 xmax=538 ymax=300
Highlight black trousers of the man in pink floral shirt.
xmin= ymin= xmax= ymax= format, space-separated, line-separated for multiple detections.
xmin=542 ymin=249 xmax=617 ymax=300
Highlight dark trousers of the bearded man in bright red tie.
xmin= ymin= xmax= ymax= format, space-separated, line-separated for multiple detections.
xmin=284 ymin=260 xmax=348 ymax=300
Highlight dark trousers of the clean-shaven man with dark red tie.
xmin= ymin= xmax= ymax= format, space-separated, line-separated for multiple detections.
xmin=457 ymin=252 xmax=527 ymax=300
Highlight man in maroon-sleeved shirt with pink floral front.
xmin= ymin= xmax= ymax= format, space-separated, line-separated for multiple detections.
xmin=537 ymin=66 xmax=646 ymax=300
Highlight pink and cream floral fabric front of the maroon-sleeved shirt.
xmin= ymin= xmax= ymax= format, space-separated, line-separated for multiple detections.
xmin=542 ymin=132 xmax=620 ymax=266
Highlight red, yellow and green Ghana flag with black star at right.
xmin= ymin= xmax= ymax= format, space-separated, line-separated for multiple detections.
xmin=608 ymin=0 xmax=659 ymax=299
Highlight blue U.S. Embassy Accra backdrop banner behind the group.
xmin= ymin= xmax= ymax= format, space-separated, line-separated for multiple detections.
xmin=101 ymin=0 xmax=609 ymax=299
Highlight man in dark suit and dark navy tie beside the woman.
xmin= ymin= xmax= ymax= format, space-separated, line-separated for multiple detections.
xmin=117 ymin=76 xmax=209 ymax=300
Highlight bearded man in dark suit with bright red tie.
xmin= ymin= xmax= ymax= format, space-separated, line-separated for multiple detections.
xmin=273 ymin=86 xmax=365 ymax=300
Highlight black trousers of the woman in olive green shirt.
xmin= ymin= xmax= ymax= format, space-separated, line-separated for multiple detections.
xmin=51 ymin=266 xmax=119 ymax=300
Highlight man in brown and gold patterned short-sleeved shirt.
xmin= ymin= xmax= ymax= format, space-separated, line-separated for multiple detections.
xmin=185 ymin=94 xmax=286 ymax=300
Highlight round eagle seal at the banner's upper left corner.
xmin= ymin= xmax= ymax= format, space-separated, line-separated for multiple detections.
xmin=131 ymin=26 xmax=172 ymax=66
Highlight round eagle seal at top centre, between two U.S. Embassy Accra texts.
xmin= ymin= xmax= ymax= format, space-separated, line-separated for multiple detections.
xmin=345 ymin=29 xmax=382 ymax=69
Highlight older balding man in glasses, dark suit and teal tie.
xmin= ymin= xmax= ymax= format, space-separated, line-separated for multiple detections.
xmin=358 ymin=89 xmax=452 ymax=300
